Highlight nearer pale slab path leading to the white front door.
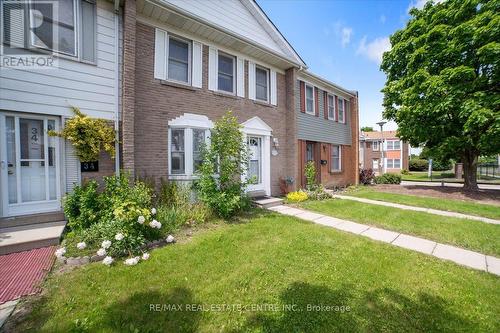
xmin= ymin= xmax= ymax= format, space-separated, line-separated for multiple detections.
xmin=268 ymin=205 xmax=500 ymax=276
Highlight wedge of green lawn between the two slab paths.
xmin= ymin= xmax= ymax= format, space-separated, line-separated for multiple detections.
xmin=300 ymin=199 xmax=500 ymax=257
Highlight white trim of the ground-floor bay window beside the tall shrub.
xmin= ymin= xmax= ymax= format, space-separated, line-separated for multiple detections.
xmin=167 ymin=113 xmax=213 ymax=180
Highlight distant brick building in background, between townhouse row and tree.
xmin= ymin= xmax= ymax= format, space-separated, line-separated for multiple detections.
xmin=359 ymin=131 xmax=410 ymax=174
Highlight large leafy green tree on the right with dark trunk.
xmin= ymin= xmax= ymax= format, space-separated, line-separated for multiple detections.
xmin=381 ymin=0 xmax=500 ymax=190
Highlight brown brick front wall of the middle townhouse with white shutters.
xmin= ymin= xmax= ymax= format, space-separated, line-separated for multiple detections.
xmin=131 ymin=23 xmax=294 ymax=194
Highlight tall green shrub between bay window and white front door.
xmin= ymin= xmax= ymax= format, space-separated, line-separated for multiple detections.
xmin=196 ymin=111 xmax=248 ymax=219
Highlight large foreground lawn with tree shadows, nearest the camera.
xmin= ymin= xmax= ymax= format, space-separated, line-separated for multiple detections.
xmin=12 ymin=213 xmax=500 ymax=332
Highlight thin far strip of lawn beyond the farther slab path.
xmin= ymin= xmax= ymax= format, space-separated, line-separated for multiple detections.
xmin=347 ymin=186 xmax=500 ymax=220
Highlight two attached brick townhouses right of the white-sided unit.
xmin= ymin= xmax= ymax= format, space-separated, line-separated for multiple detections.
xmin=122 ymin=0 xmax=358 ymax=195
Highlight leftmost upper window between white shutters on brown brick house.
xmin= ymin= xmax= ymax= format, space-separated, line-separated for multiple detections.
xmin=167 ymin=36 xmax=191 ymax=83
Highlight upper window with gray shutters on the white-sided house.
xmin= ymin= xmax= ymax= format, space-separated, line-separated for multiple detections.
xmin=1 ymin=0 xmax=97 ymax=62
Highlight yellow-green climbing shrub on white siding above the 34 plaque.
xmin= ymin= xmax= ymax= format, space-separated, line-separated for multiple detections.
xmin=49 ymin=107 xmax=115 ymax=162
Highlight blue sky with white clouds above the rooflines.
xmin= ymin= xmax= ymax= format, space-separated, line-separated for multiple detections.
xmin=257 ymin=0 xmax=425 ymax=130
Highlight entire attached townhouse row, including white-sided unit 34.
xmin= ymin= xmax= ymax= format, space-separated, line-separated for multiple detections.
xmin=0 ymin=0 xmax=358 ymax=227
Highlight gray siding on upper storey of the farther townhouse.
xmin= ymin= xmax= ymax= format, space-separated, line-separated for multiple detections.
xmin=295 ymin=81 xmax=352 ymax=145
